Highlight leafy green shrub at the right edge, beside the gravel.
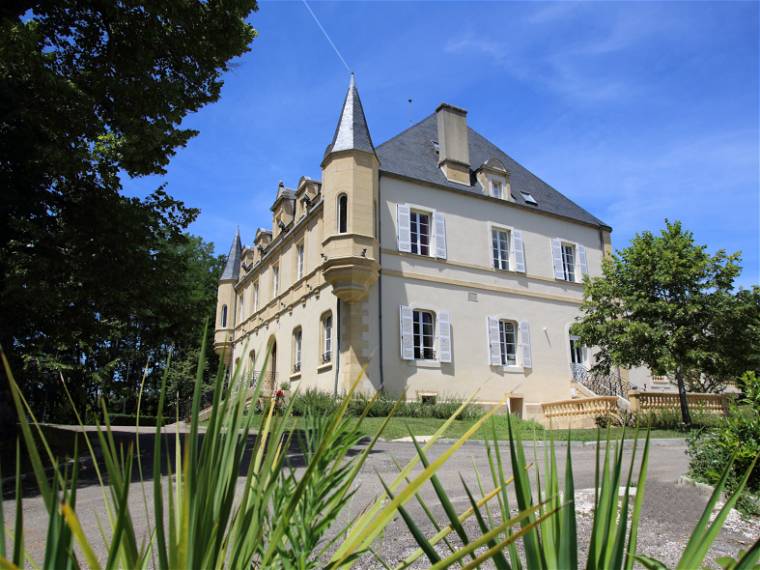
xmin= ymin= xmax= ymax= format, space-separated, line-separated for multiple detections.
xmin=688 ymin=372 xmax=760 ymax=514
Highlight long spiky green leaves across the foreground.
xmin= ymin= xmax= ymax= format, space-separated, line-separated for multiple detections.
xmin=0 ymin=340 xmax=760 ymax=570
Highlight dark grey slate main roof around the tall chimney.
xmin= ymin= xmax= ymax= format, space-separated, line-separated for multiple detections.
xmin=376 ymin=113 xmax=609 ymax=227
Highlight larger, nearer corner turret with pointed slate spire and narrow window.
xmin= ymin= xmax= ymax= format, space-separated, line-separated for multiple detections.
xmin=322 ymin=74 xmax=379 ymax=303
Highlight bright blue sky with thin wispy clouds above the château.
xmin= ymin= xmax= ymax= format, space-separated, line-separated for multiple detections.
xmin=125 ymin=1 xmax=760 ymax=285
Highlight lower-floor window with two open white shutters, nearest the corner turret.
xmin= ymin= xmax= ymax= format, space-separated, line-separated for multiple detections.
xmin=399 ymin=305 xmax=452 ymax=362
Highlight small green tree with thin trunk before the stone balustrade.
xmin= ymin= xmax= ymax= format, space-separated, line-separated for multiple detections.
xmin=573 ymin=220 xmax=747 ymax=425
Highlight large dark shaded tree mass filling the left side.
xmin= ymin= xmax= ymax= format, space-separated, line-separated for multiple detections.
xmin=0 ymin=0 xmax=256 ymax=426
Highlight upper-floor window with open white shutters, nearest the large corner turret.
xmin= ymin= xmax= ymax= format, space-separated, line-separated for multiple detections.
xmin=396 ymin=204 xmax=446 ymax=259
